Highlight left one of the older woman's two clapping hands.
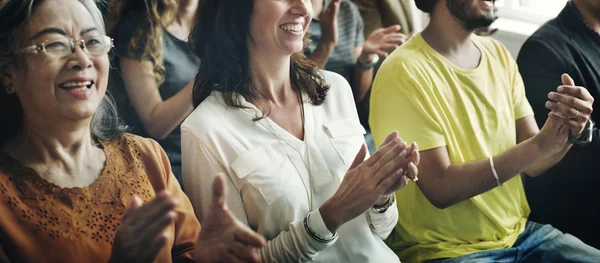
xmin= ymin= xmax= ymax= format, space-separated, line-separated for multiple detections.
xmin=109 ymin=191 xmax=177 ymax=263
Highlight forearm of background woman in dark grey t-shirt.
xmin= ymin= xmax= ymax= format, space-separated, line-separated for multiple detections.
xmin=144 ymin=80 xmax=194 ymax=139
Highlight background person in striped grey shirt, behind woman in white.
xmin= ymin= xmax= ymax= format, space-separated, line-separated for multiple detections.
xmin=306 ymin=0 xmax=405 ymax=152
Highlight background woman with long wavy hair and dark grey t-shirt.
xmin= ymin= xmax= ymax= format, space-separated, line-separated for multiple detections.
xmin=108 ymin=0 xmax=200 ymax=188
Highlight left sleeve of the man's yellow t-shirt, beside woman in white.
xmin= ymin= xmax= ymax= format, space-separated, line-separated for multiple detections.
xmin=369 ymin=57 xmax=446 ymax=150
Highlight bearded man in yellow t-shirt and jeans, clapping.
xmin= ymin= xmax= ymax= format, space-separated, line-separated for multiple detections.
xmin=370 ymin=0 xmax=600 ymax=263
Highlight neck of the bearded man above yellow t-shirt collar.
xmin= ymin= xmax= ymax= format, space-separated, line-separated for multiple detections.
xmin=421 ymin=1 xmax=473 ymax=55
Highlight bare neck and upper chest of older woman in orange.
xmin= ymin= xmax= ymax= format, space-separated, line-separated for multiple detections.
xmin=5 ymin=118 xmax=98 ymax=164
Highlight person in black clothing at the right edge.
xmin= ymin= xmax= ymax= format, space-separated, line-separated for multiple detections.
xmin=517 ymin=0 xmax=600 ymax=251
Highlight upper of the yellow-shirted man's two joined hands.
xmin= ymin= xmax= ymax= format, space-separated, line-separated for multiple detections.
xmin=546 ymin=74 xmax=594 ymax=139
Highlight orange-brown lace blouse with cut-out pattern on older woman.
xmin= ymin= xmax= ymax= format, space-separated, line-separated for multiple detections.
xmin=0 ymin=134 xmax=200 ymax=263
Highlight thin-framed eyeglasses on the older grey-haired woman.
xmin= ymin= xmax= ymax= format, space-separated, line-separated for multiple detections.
xmin=17 ymin=35 xmax=114 ymax=58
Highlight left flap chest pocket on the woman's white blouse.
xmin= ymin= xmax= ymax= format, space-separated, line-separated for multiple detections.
xmin=231 ymin=145 xmax=289 ymax=205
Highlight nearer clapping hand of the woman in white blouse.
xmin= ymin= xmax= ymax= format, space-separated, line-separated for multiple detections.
xmin=320 ymin=132 xmax=411 ymax=233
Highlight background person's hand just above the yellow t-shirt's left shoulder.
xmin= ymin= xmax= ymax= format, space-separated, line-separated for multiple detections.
xmin=362 ymin=25 xmax=406 ymax=58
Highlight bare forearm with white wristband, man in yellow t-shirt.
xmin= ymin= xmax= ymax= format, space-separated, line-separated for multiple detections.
xmin=426 ymin=137 xmax=547 ymax=209
